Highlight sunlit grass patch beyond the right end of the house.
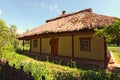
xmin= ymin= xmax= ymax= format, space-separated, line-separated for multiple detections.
xmin=108 ymin=47 xmax=120 ymax=64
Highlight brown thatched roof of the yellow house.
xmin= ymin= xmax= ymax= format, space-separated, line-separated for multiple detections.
xmin=19 ymin=8 xmax=118 ymax=38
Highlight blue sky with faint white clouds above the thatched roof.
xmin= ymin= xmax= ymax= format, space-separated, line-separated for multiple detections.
xmin=0 ymin=0 xmax=120 ymax=33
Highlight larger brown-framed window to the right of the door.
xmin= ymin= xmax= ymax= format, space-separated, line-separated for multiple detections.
xmin=80 ymin=38 xmax=91 ymax=51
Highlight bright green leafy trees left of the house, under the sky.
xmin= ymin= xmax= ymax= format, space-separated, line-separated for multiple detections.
xmin=0 ymin=20 xmax=17 ymax=54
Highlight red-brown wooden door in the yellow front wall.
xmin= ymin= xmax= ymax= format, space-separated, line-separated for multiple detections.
xmin=50 ymin=38 xmax=58 ymax=55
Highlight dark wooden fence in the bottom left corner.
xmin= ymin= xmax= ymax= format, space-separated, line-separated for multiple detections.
xmin=0 ymin=60 xmax=34 ymax=80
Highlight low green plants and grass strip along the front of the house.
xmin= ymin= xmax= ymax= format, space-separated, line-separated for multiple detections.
xmin=2 ymin=50 xmax=120 ymax=80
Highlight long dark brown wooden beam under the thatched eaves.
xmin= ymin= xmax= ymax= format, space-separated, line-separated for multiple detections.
xmin=18 ymin=29 xmax=95 ymax=40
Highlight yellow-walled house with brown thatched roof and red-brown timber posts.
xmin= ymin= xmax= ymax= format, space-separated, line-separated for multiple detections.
xmin=19 ymin=8 xmax=117 ymax=65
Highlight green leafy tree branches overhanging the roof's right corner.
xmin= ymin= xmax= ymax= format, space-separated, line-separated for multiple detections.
xmin=95 ymin=20 xmax=120 ymax=43
